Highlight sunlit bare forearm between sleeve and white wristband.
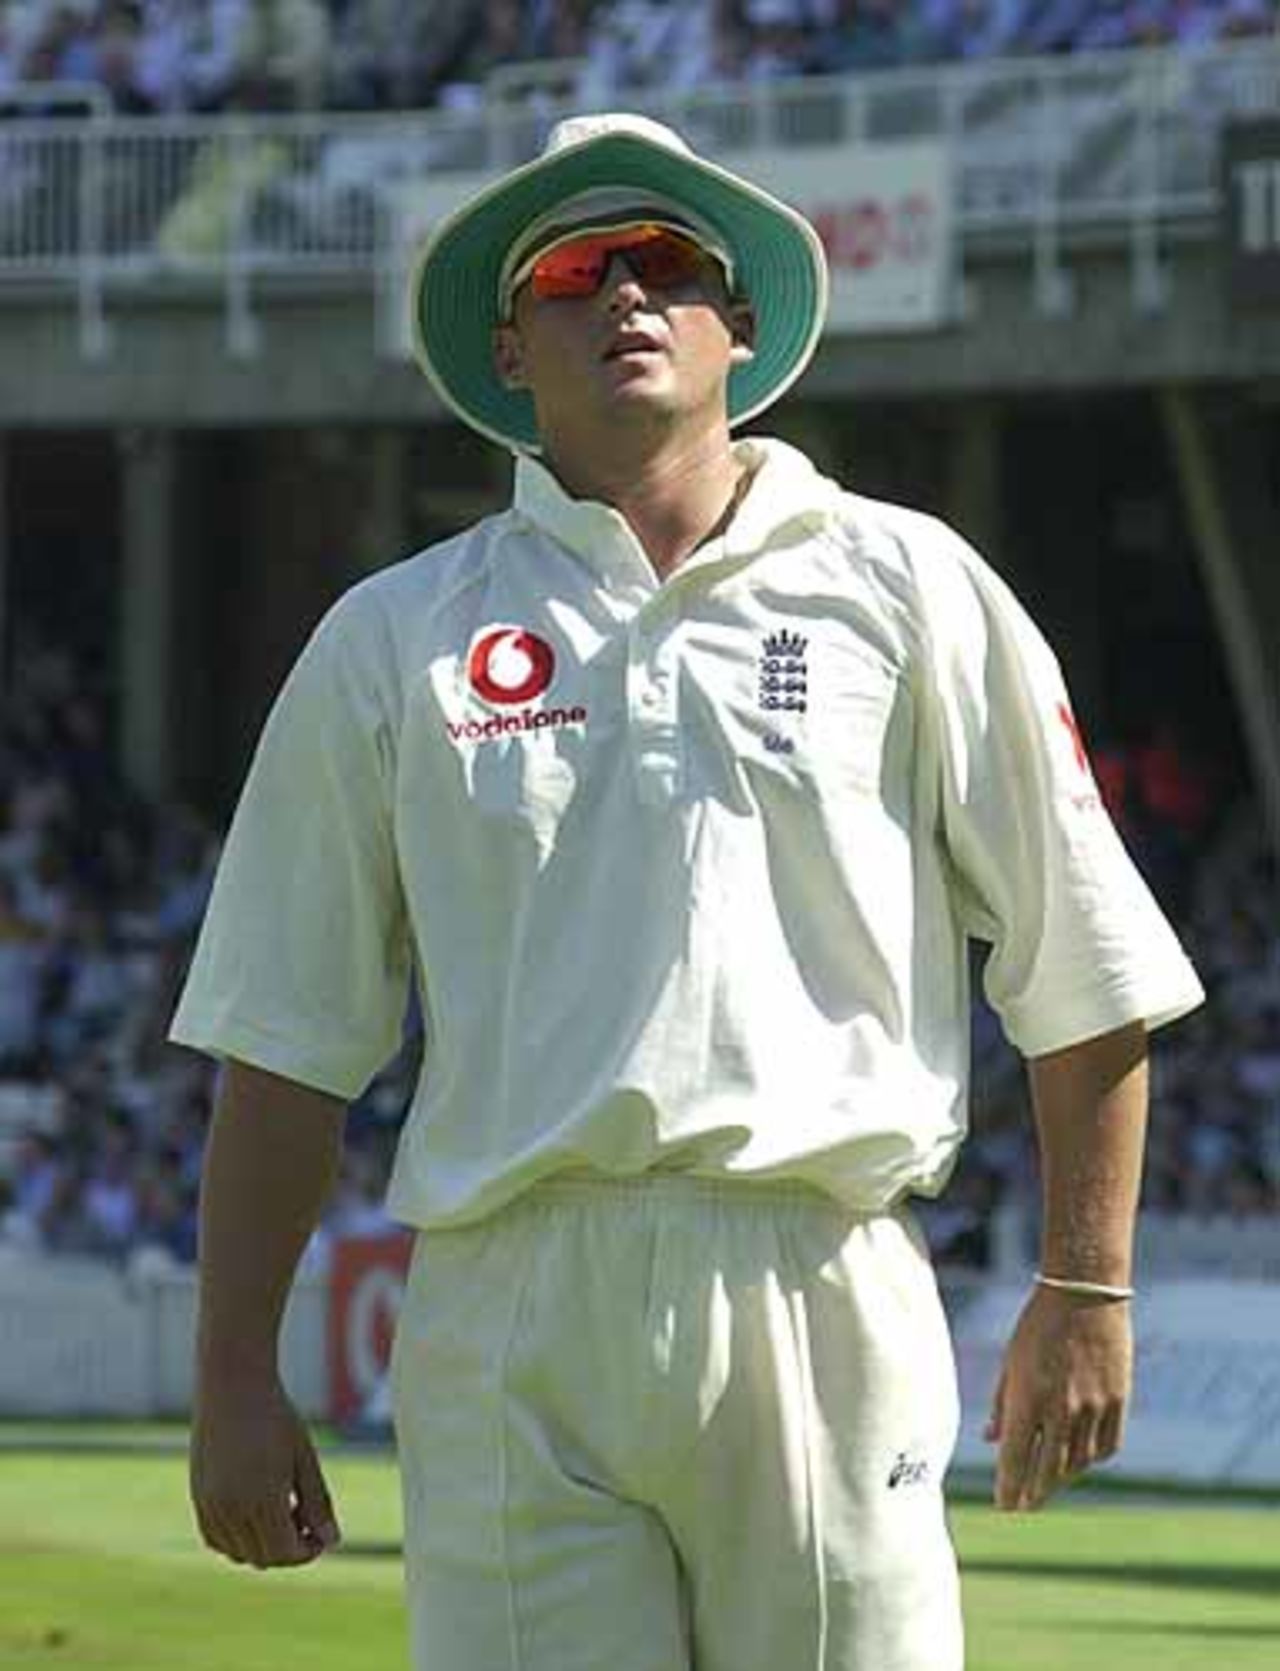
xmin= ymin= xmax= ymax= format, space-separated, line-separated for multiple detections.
xmin=1029 ymin=1024 xmax=1148 ymax=1283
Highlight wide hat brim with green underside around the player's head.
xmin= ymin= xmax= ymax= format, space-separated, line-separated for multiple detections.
xmin=409 ymin=134 xmax=827 ymax=453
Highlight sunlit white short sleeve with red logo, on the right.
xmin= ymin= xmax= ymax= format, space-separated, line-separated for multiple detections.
xmin=917 ymin=525 xmax=1203 ymax=1056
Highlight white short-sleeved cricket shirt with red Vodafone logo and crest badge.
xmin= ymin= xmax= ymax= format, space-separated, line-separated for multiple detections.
xmin=172 ymin=441 xmax=1203 ymax=1227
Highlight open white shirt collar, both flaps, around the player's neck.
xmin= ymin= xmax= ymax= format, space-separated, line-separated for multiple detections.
xmin=511 ymin=436 xmax=837 ymax=587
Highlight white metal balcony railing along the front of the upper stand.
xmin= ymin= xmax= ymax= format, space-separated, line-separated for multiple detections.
xmin=0 ymin=40 xmax=1280 ymax=354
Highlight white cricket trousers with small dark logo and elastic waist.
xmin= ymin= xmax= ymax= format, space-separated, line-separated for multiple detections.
xmin=393 ymin=1176 xmax=964 ymax=1671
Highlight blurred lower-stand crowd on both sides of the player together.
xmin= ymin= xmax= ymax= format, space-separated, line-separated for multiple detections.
xmin=0 ymin=631 xmax=1280 ymax=1265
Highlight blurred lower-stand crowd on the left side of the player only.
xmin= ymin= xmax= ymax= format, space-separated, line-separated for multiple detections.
xmin=0 ymin=634 xmax=413 ymax=1263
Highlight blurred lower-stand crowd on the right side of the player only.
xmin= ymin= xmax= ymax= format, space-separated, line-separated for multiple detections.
xmin=929 ymin=725 xmax=1280 ymax=1265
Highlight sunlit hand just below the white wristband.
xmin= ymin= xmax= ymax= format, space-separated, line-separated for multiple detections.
xmin=986 ymin=1287 xmax=1133 ymax=1509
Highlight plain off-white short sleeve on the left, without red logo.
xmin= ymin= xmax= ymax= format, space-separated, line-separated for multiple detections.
xmin=170 ymin=595 xmax=411 ymax=1100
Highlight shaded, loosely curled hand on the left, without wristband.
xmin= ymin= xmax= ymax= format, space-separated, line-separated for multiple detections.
xmin=190 ymin=1380 xmax=341 ymax=1567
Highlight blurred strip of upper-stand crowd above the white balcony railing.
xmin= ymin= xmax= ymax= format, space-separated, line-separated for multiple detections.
xmin=0 ymin=0 xmax=1277 ymax=115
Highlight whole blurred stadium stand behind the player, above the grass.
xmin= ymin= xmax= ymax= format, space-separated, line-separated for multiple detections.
xmin=0 ymin=0 xmax=1280 ymax=1487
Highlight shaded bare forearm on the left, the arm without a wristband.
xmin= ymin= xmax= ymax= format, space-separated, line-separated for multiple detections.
xmin=197 ymin=1063 xmax=346 ymax=1380
